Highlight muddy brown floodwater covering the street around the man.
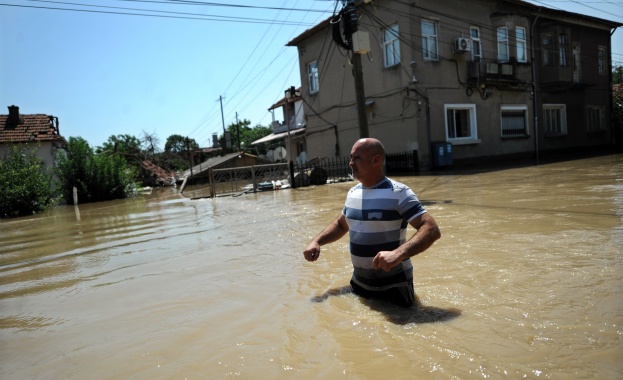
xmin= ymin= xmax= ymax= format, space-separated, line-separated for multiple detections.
xmin=0 ymin=155 xmax=623 ymax=379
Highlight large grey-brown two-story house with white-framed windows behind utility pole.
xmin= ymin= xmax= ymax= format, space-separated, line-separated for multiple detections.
xmin=288 ymin=0 xmax=621 ymax=169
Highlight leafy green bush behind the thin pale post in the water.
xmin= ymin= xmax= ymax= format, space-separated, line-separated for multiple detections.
xmin=57 ymin=137 xmax=137 ymax=204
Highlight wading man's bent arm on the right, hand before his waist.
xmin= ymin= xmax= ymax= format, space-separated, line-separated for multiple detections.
xmin=373 ymin=213 xmax=441 ymax=272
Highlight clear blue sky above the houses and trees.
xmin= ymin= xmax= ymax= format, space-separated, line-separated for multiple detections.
xmin=0 ymin=0 xmax=623 ymax=148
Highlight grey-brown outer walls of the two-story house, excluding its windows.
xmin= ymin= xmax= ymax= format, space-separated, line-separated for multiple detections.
xmin=295 ymin=0 xmax=611 ymax=168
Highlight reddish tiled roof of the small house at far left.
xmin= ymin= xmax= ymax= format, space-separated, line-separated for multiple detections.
xmin=0 ymin=114 xmax=66 ymax=144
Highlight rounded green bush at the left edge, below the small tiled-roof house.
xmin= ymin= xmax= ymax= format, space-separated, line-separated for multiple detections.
xmin=0 ymin=146 xmax=56 ymax=216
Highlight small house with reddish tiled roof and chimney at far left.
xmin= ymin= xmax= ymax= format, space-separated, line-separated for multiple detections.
xmin=0 ymin=106 xmax=67 ymax=168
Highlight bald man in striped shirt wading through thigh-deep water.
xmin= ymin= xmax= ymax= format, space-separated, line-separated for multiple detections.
xmin=303 ymin=138 xmax=441 ymax=307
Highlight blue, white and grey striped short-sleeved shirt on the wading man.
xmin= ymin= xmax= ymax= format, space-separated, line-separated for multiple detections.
xmin=342 ymin=178 xmax=426 ymax=291
